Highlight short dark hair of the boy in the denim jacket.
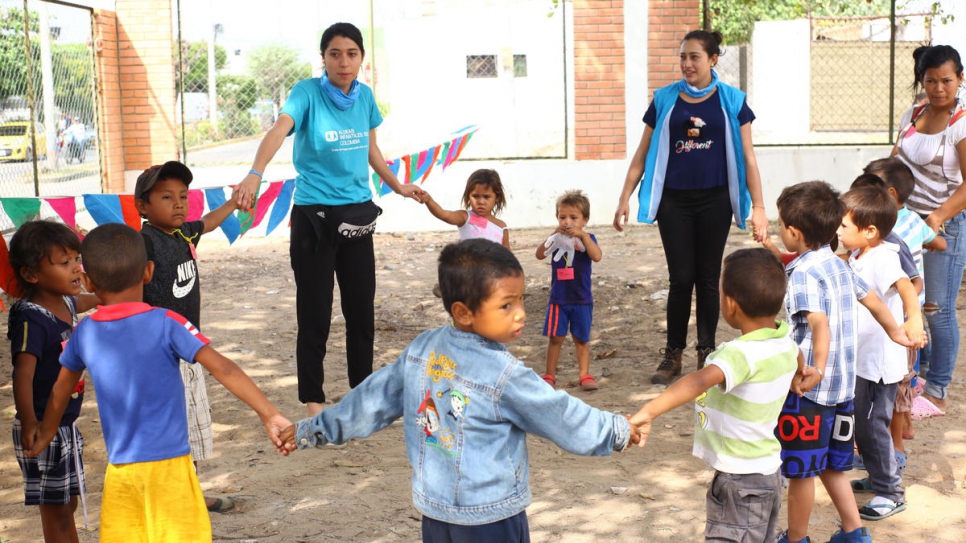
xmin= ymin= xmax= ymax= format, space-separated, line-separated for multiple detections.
xmin=439 ymin=239 xmax=523 ymax=315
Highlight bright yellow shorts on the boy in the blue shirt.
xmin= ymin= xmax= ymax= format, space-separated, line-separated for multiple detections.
xmin=101 ymin=455 xmax=211 ymax=543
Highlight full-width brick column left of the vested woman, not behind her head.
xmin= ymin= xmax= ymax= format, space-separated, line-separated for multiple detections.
xmin=573 ymin=0 xmax=637 ymax=160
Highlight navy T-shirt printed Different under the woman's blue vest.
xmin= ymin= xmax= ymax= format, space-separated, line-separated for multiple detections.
xmin=644 ymin=92 xmax=755 ymax=190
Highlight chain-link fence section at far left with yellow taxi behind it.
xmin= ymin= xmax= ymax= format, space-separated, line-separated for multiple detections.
xmin=0 ymin=0 xmax=101 ymax=197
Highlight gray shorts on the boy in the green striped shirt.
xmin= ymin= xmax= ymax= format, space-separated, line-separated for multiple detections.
xmin=704 ymin=470 xmax=782 ymax=543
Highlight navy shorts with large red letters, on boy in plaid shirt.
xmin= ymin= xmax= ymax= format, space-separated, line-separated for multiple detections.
xmin=775 ymin=392 xmax=855 ymax=479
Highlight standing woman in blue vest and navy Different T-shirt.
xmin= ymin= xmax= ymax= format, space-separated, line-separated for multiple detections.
xmin=614 ymin=30 xmax=768 ymax=384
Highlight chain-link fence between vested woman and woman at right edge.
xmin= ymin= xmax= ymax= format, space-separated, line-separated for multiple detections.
xmin=707 ymin=0 xmax=942 ymax=145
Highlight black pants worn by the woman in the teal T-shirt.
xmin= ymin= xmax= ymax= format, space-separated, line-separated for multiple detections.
xmin=289 ymin=206 xmax=376 ymax=403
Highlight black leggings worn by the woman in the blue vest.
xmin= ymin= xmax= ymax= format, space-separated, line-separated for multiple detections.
xmin=657 ymin=187 xmax=733 ymax=349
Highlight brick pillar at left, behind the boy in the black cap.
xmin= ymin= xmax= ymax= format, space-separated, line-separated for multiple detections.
xmin=95 ymin=0 xmax=179 ymax=192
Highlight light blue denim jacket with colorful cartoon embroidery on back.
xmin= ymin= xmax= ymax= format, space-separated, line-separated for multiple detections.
xmin=295 ymin=325 xmax=630 ymax=525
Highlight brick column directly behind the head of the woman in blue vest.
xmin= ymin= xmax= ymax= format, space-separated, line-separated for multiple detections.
xmin=647 ymin=0 xmax=701 ymax=94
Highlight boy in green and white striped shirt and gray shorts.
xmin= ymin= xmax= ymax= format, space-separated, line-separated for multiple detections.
xmin=630 ymin=248 xmax=800 ymax=543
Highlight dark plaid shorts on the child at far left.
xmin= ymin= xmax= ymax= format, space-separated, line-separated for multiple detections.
xmin=13 ymin=419 xmax=84 ymax=505
